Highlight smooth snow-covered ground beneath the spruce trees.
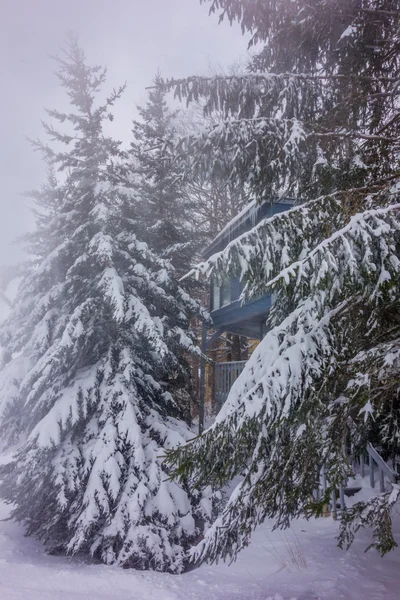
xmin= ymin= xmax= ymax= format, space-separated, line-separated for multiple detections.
xmin=0 ymin=494 xmax=400 ymax=600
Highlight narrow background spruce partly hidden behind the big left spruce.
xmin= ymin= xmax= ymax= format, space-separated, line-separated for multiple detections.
xmin=127 ymin=74 xmax=212 ymax=414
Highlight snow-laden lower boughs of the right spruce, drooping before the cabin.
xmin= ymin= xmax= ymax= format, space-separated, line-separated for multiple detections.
xmin=167 ymin=194 xmax=400 ymax=561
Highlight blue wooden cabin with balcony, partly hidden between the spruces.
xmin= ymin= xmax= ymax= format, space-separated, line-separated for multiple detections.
xmin=199 ymin=199 xmax=293 ymax=432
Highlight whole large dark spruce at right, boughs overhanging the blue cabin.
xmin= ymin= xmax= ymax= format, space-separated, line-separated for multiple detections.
xmin=161 ymin=0 xmax=400 ymax=560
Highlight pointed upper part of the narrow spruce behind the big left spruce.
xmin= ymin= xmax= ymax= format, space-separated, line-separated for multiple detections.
xmin=131 ymin=75 xmax=198 ymax=277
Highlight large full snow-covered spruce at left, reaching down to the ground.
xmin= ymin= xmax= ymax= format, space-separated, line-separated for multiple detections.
xmin=0 ymin=41 xmax=211 ymax=572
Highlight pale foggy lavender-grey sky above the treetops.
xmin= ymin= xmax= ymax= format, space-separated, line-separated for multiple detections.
xmin=0 ymin=0 xmax=247 ymax=274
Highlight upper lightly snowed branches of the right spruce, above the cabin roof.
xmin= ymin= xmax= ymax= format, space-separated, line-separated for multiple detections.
xmin=162 ymin=0 xmax=400 ymax=200
